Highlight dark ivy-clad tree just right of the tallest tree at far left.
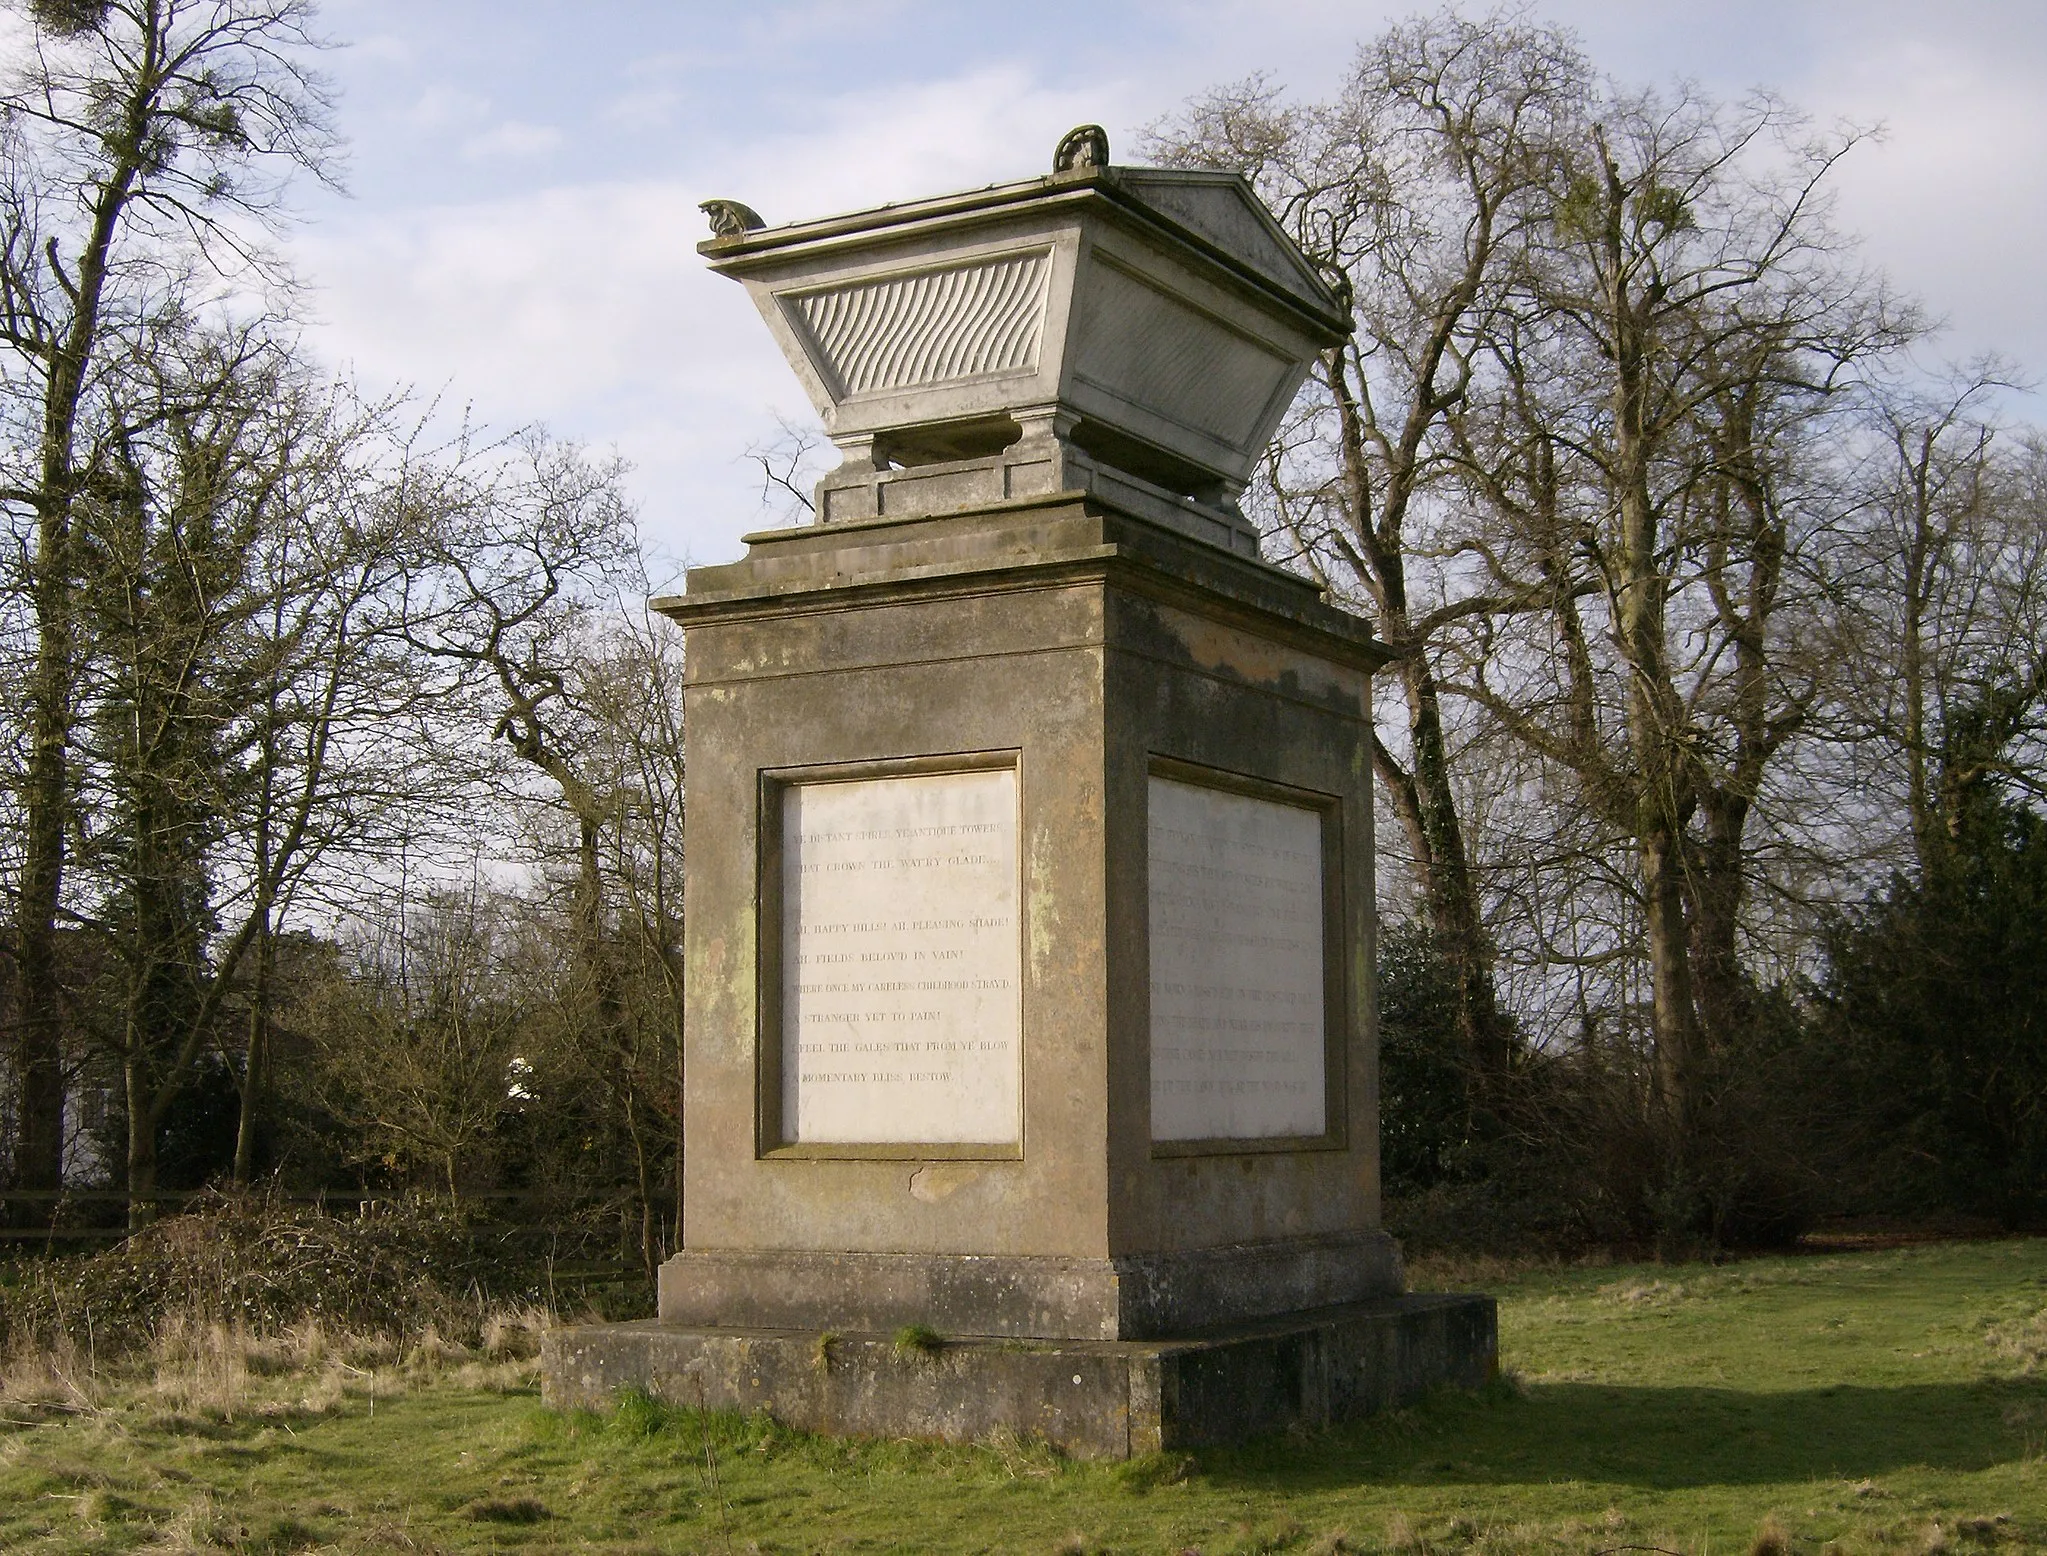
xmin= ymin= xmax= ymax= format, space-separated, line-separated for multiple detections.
xmin=76 ymin=325 xmax=266 ymax=1214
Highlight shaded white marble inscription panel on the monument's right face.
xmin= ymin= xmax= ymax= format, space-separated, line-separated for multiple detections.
xmin=1150 ymin=778 xmax=1329 ymax=1140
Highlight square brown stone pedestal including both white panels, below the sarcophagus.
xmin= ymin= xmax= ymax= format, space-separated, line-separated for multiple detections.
xmin=661 ymin=495 xmax=1402 ymax=1339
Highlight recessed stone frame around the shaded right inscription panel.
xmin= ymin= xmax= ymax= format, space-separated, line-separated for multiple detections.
xmin=1144 ymin=755 xmax=1355 ymax=1157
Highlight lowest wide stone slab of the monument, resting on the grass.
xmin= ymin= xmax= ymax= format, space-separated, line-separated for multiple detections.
xmin=542 ymin=1296 xmax=1498 ymax=1458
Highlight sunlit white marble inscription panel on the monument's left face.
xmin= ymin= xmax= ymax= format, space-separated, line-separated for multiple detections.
xmin=782 ymin=768 xmax=1021 ymax=1144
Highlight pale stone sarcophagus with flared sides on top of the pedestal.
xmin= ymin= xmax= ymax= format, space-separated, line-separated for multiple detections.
xmin=704 ymin=125 xmax=1349 ymax=555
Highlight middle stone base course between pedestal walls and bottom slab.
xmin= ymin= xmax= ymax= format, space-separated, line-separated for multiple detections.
xmin=655 ymin=1230 xmax=1406 ymax=1339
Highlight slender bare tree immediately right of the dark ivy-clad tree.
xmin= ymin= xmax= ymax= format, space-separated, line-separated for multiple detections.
xmin=213 ymin=385 xmax=479 ymax=1183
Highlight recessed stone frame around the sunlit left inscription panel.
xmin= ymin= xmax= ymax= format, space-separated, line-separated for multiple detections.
xmin=755 ymin=751 xmax=1026 ymax=1161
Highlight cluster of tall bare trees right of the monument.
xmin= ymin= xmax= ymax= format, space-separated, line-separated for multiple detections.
xmin=1146 ymin=10 xmax=2043 ymax=1216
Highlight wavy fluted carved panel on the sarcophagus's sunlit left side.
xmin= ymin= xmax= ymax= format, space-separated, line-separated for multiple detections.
xmin=788 ymin=250 xmax=1052 ymax=399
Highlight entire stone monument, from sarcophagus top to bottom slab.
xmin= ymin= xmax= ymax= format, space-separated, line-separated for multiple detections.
xmin=547 ymin=127 xmax=1494 ymax=1456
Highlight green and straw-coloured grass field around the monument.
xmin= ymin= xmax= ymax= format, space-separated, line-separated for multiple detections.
xmin=0 ymin=1241 xmax=2047 ymax=1556
